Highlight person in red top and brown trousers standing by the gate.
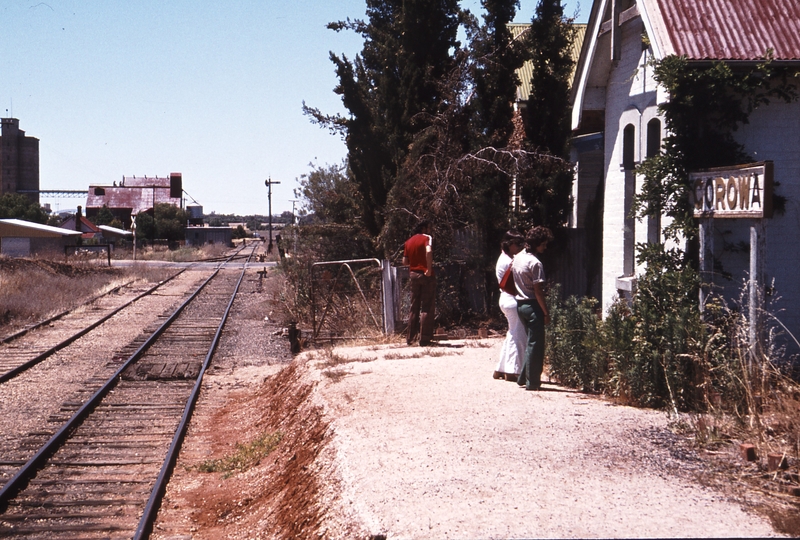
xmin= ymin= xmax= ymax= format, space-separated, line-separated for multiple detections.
xmin=403 ymin=221 xmax=436 ymax=347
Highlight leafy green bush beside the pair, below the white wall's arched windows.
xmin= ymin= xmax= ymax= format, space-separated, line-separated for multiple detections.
xmin=548 ymin=245 xmax=724 ymax=410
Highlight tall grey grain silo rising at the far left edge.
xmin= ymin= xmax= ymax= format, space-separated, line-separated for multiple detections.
xmin=0 ymin=118 xmax=39 ymax=203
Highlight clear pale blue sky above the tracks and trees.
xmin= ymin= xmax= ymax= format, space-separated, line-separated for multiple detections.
xmin=0 ymin=0 xmax=591 ymax=215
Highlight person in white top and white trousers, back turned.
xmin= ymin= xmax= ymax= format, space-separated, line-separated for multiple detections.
xmin=492 ymin=229 xmax=527 ymax=382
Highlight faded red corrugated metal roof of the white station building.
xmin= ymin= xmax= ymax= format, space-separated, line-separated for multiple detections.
xmin=657 ymin=0 xmax=800 ymax=60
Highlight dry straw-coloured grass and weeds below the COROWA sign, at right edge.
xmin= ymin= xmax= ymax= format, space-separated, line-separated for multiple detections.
xmin=672 ymin=293 xmax=800 ymax=537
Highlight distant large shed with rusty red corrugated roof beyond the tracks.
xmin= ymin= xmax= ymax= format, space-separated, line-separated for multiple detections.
xmin=86 ymin=173 xmax=183 ymax=229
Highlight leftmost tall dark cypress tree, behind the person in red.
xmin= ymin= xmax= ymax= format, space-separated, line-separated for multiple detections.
xmin=306 ymin=0 xmax=459 ymax=240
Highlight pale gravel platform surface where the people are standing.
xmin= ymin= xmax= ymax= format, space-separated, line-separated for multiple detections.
xmin=310 ymin=339 xmax=775 ymax=538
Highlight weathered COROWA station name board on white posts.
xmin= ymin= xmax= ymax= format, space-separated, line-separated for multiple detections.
xmin=689 ymin=161 xmax=772 ymax=218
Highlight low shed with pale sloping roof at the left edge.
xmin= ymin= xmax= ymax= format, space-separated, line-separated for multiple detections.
xmin=0 ymin=219 xmax=81 ymax=257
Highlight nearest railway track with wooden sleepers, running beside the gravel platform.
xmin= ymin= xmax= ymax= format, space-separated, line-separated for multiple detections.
xmin=0 ymin=246 xmax=254 ymax=539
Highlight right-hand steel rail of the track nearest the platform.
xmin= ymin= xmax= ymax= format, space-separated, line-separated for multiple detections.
xmin=133 ymin=249 xmax=255 ymax=540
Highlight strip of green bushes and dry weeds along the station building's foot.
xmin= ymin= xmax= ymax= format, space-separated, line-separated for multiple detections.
xmin=547 ymin=266 xmax=800 ymax=498
